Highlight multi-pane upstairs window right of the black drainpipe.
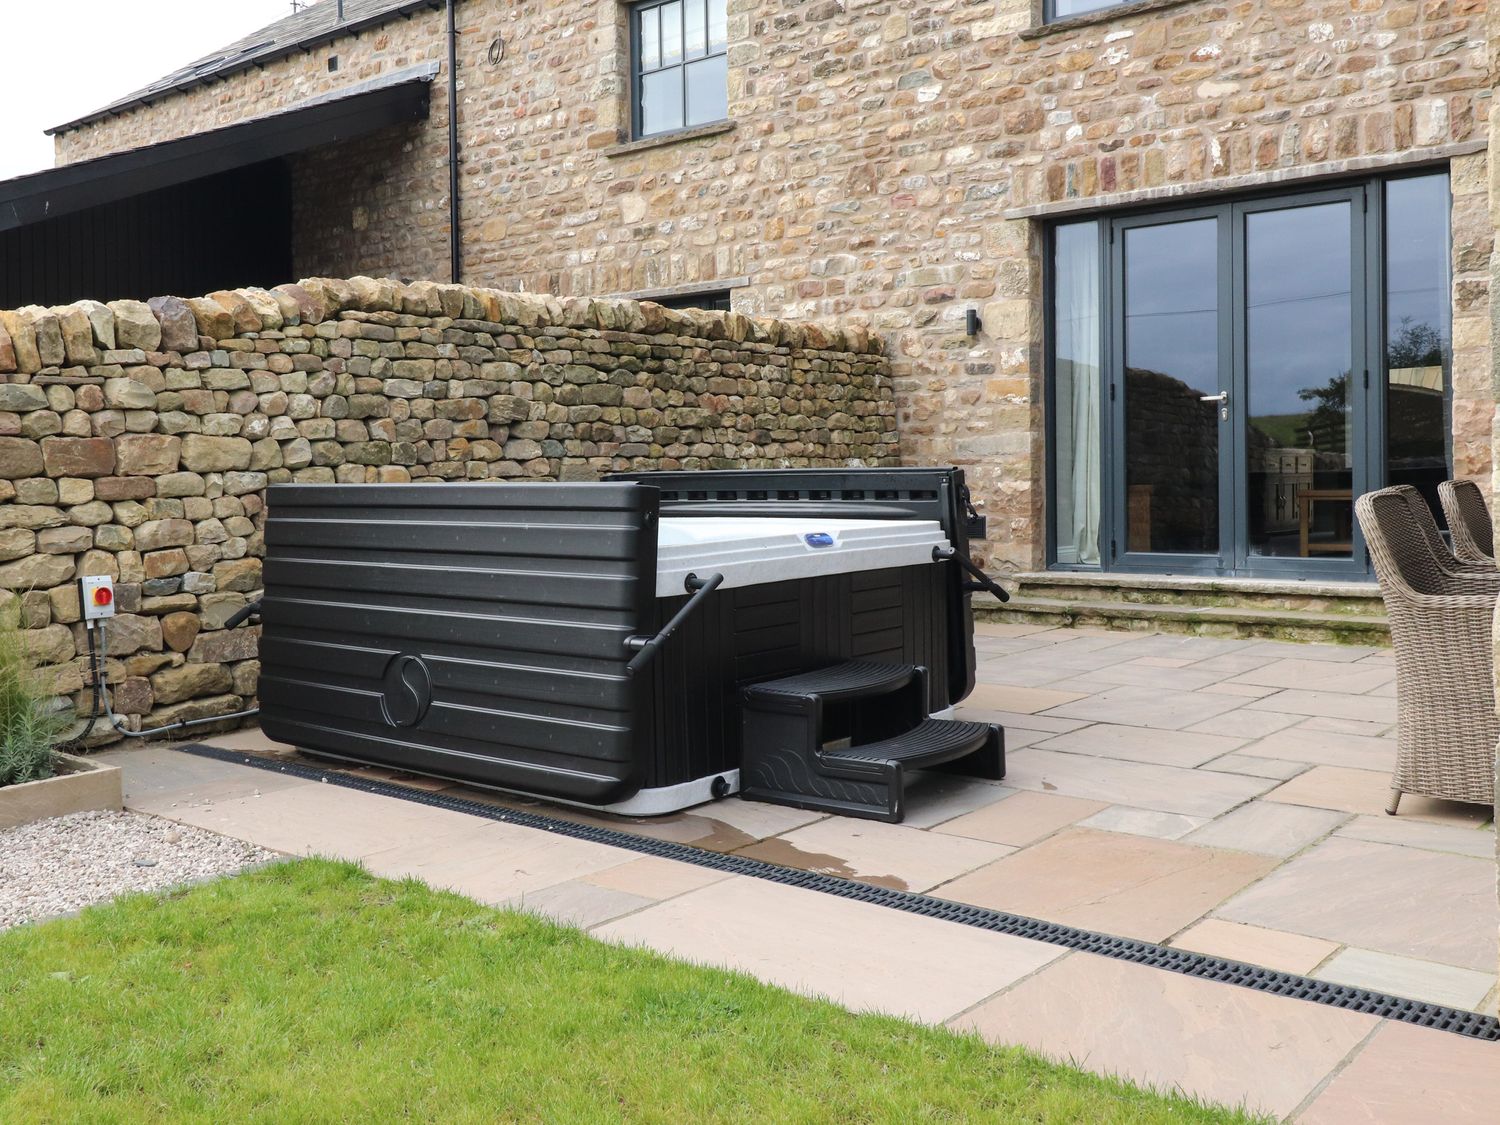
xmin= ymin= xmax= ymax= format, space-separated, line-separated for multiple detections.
xmin=630 ymin=0 xmax=729 ymax=138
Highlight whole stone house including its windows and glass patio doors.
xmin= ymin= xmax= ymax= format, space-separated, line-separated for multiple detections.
xmin=0 ymin=0 xmax=1494 ymax=594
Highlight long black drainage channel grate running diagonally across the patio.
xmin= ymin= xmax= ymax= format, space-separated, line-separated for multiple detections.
xmin=176 ymin=744 xmax=1500 ymax=1043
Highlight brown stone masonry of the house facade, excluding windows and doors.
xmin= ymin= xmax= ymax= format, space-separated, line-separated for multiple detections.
xmin=49 ymin=0 xmax=1494 ymax=569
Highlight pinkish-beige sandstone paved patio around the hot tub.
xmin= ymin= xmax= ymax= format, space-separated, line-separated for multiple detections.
xmin=99 ymin=624 xmax=1500 ymax=1121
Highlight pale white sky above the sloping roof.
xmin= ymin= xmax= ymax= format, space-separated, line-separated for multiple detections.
xmin=0 ymin=0 xmax=295 ymax=180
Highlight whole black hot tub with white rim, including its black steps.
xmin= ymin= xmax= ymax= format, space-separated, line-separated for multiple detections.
xmin=260 ymin=470 xmax=1004 ymax=821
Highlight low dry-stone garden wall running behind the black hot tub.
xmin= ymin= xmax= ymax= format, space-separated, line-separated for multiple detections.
xmin=0 ymin=278 xmax=897 ymax=741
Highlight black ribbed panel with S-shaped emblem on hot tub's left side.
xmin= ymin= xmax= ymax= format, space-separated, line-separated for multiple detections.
xmin=260 ymin=483 xmax=657 ymax=804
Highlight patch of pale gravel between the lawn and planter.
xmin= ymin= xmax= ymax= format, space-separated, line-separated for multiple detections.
xmin=0 ymin=813 xmax=276 ymax=930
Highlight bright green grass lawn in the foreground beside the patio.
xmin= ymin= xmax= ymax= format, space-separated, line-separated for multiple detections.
xmin=0 ymin=861 xmax=1245 ymax=1125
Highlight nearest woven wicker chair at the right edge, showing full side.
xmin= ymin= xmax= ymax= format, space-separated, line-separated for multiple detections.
xmin=1355 ymin=488 xmax=1500 ymax=815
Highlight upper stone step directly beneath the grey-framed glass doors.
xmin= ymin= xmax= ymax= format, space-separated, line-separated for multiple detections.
xmin=1017 ymin=572 xmax=1386 ymax=618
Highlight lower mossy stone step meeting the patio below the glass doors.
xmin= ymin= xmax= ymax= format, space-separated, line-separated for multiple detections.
xmin=974 ymin=594 xmax=1391 ymax=647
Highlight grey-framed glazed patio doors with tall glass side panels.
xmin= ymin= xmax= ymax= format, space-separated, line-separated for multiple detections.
xmin=1050 ymin=176 xmax=1448 ymax=579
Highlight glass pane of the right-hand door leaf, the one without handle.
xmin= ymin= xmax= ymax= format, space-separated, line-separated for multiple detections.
xmin=1245 ymin=201 xmax=1355 ymax=558
